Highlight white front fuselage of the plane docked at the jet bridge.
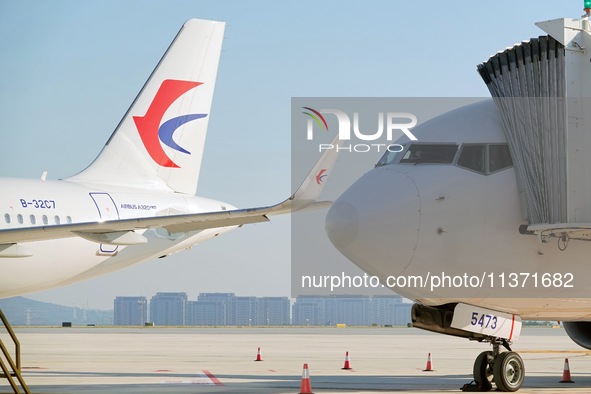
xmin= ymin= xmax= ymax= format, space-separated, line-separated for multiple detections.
xmin=326 ymin=101 xmax=591 ymax=321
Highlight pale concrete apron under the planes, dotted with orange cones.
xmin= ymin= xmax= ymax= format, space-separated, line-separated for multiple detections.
xmin=0 ymin=327 xmax=591 ymax=394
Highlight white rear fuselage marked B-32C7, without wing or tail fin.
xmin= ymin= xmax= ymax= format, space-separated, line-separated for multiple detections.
xmin=0 ymin=178 xmax=236 ymax=298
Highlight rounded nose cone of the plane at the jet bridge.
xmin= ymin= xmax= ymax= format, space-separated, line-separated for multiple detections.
xmin=325 ymin=168 xmax=420 ymax=276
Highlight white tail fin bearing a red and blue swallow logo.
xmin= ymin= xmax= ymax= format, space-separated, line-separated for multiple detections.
xmin=68 ymin=19 xmax=225 ymax=194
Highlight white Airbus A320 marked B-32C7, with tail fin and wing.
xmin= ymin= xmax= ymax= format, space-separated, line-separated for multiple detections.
xmin=0 ymin=20 xmax=336 ymax=298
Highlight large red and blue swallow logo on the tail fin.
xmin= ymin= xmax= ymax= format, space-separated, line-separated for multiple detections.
xmin=133 ymin=79 xmax=207 ymax=168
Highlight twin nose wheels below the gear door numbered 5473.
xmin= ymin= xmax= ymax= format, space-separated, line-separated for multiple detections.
xmin=474 ymin=338 xmax=525 ymax=392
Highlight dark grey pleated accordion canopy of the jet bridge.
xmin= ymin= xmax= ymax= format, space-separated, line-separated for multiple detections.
xmin=478 ymin=36 xmax=569 ymax=226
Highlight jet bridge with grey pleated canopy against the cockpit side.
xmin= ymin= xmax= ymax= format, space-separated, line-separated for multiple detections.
xmin=478 ymin=15 xmax=591 ymax=242
